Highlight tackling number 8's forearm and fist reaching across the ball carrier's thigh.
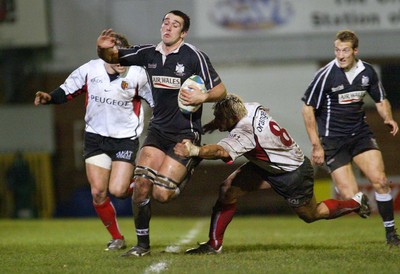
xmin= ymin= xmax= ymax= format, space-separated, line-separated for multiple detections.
xmin=174 ymin=140 xmax=231 ymax=160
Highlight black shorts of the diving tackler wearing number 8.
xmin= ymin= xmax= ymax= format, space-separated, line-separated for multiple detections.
xmin=254 ymin=157 xmax=314 ymax=207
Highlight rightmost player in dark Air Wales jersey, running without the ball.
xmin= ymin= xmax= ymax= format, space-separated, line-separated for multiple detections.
xmin=302 ymin=30 xmax=400 ymax=246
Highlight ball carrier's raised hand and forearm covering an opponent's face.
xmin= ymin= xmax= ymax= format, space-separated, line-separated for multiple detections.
xmin=97 ymin=29 xmax=119 ymax=64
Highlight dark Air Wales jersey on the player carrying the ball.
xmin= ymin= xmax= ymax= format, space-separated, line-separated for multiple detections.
xmin=119 ymin=43 xmax=221 ymax=136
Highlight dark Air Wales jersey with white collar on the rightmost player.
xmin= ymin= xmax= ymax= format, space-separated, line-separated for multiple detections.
xmin=302 ymin=59 xmax=386 ymax=137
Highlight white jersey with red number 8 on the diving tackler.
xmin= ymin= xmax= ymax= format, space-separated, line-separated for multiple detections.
xmin=218 ymin=103 xmax=304 ymax=173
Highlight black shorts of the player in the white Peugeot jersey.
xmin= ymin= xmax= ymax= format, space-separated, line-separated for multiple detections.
xmin=83 ymin=132 xmax=139 ymax=164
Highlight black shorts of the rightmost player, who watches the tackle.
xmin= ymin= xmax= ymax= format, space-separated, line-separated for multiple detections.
xmin=321 ymin=131 xmax=379 ymax=172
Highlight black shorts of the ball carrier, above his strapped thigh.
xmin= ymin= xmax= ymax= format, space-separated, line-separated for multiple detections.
xmin=142 ymin=128 xmax=201 ymax=166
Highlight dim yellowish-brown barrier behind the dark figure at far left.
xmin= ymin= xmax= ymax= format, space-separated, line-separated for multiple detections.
xmin=0 ymin=152 xmax=55 ymax=218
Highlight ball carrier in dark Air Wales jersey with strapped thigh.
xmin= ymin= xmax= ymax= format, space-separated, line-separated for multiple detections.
xmin=97 ymin=10 xmax=226 ymax=256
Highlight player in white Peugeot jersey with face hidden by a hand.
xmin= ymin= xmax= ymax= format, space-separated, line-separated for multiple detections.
xmin=34 ymin=34 xmax=154 ymax=250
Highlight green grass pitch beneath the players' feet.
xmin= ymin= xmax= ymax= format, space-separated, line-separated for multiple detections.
xmin=0 ymin=215 xmax=400 ymax=274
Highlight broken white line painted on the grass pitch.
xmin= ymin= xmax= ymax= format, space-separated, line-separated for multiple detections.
xmin=144 ymin=221 xmax=205 ymax=274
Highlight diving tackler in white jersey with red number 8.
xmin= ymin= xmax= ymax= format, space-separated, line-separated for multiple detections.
xmin=175 ymin=94 xmax=366 ymax=254
